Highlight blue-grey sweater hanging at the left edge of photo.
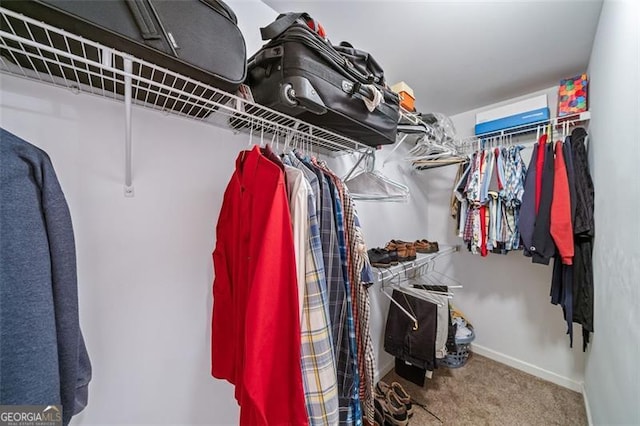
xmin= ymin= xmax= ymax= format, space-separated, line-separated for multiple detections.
xmin=0 ymin=129 xmax=91 ymax=425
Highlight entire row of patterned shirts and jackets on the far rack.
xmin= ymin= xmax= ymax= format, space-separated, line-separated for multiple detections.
xmin=452 ymin=127 xmax=594 ymax=350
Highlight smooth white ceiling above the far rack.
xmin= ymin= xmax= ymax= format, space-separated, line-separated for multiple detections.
xmin=258 ymin=0 xmax=602 ymax=115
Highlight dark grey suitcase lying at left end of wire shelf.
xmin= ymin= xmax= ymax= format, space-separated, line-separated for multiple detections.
xmin=1 ymin=0 xmax=246 ymax=116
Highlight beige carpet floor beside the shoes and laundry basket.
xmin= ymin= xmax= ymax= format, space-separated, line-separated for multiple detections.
xmin=383 ymin=354 xmax=588 ymax=426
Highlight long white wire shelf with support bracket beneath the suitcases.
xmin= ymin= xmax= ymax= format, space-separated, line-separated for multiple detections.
xmin=0 ymin=7 xmax=370 ymax=196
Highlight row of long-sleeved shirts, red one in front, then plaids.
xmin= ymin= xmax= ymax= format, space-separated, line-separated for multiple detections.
xmin=212 ymin=146 xmax=374 ymax=425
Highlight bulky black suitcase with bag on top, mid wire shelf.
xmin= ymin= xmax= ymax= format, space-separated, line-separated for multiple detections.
xmin=247 ymin=13 xmax=400 ymax=146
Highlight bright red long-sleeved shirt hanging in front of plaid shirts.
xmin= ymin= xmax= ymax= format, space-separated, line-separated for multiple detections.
xmin=211 ymin=147 xmax=308 ymax=426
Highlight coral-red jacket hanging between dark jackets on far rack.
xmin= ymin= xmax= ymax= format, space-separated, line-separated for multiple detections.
xmin=551 ymin=142 xmax=573 ymax=265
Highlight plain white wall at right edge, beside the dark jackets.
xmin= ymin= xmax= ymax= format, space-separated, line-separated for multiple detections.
xmin=585 ymin=0 xmax=640 ymax=425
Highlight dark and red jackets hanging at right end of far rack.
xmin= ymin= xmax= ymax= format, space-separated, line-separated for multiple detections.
xmin=521 ymin=128 xmax=594 ymax=349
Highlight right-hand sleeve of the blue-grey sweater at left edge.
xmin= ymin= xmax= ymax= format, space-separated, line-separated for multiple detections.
xmin=42 ymin=157 xmax=91 ymax=425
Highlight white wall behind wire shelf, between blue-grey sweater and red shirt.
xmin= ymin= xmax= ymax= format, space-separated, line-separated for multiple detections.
xmin=0 ymin=0 xmax=275 ymax=425
